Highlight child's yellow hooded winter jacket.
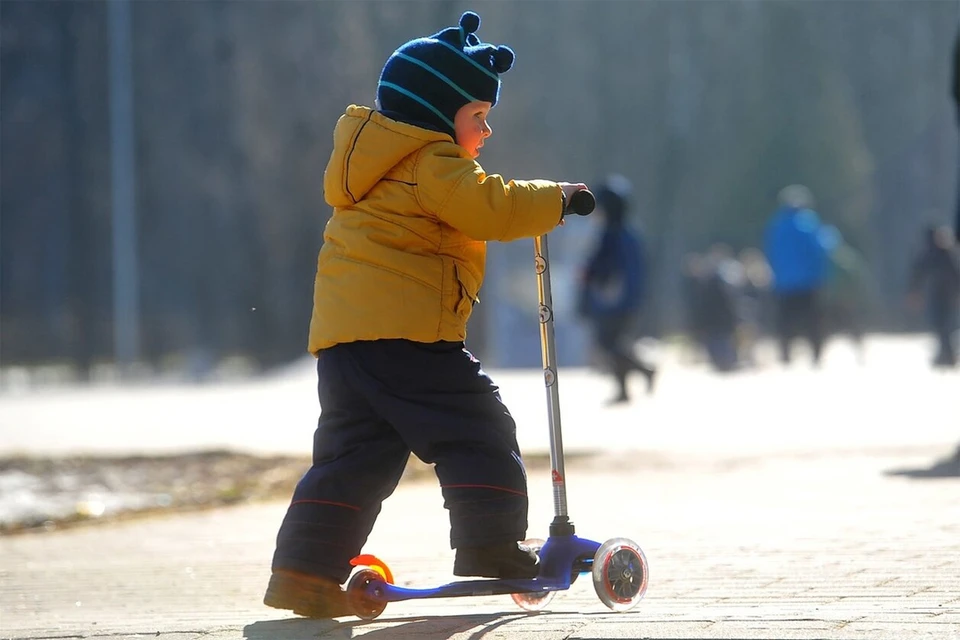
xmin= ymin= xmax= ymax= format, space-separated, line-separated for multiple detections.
xmin=308 ymin=106 xmax=562 ymax=354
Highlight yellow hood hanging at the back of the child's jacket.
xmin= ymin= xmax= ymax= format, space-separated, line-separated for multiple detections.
xmin=323 ymin=105 xmax=453 ymax=207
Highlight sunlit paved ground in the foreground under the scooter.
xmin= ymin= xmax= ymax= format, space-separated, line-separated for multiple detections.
xmin=0 ymin=451 xmax=960 ymax=640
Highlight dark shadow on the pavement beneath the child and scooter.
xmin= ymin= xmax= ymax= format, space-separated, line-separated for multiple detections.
xmin=243 ymin=613 xmax=539 ymax=640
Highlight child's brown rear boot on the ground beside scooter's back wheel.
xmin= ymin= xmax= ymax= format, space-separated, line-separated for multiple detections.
xmin=263 ymin=569 xmax=353 ymax=618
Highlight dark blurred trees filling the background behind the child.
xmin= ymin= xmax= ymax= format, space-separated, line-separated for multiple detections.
xmin=0 ymin=0 xmax=960 ymax=370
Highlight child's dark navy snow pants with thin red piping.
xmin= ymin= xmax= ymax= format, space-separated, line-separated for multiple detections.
xmin=273 ymin=340 xmax=527 ymax=583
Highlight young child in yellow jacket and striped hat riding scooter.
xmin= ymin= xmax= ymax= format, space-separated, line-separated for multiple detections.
xmin=264 ymin=12 xmax=586 ymax=618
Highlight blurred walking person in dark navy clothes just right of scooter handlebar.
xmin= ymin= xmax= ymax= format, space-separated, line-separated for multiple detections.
xmin=580 ymin=175 xmax=656 ymax=404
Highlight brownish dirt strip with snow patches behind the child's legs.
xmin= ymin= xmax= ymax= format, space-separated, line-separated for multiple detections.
xmin=0 ymin=451 xmax=568 ymax=535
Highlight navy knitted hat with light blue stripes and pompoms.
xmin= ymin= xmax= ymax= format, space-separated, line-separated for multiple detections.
xmin=377 ymin=11 xmax=514 ymax=136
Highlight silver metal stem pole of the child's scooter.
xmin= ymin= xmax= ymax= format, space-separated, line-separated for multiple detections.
xmin=533 ymin=234 xmax=567 ymax=519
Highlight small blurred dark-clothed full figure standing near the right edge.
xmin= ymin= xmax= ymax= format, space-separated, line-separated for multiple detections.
xmin=908 ymin=226 xmax=960 ymax=367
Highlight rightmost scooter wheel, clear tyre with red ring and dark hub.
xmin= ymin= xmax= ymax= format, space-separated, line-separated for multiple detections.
xmin=593 ymin=538 xmax=650 ymax=611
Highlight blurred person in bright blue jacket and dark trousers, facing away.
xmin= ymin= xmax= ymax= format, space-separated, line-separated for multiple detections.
xmin=764 ymin=185 xmax=833 ymax=364
